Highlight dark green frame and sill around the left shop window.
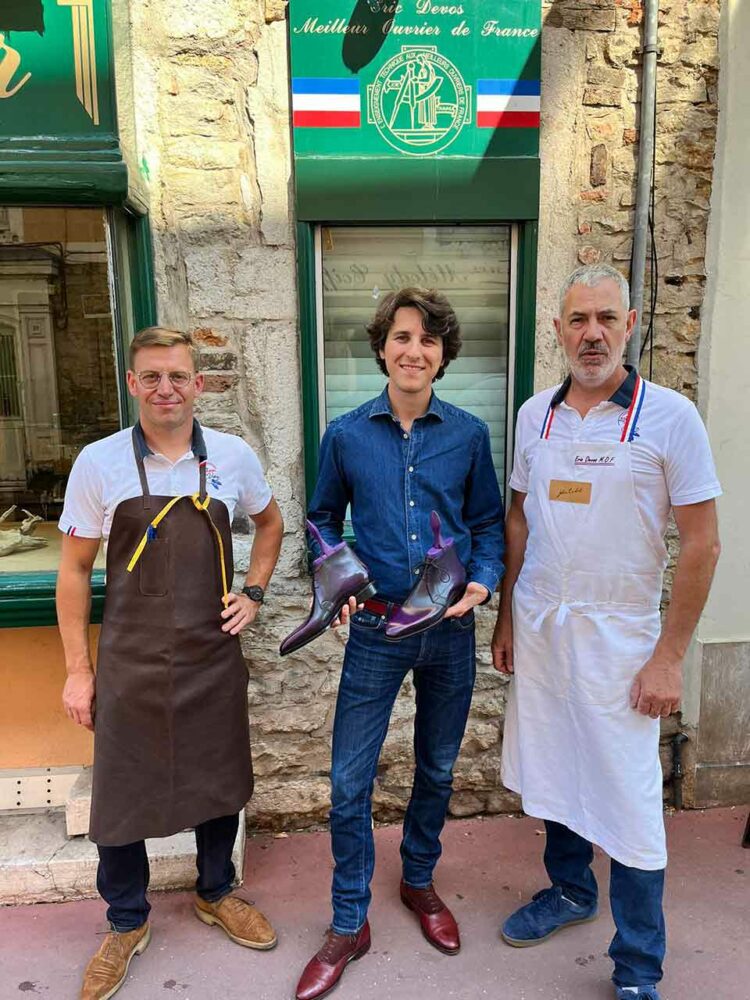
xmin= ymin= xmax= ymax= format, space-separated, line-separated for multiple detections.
xmin=0 ymin=202 xmax=156 ymax=628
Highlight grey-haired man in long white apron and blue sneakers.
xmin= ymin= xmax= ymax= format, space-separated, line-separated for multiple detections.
xmin=492 ymin=265 xmax=721 ymax=1000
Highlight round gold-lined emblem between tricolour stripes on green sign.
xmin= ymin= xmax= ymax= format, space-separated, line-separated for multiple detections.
xmin=367 ymin=45 xmax=471 ymax=156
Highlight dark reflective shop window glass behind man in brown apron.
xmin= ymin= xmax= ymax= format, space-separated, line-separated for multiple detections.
xmin=0 ymin=208 xmax=122 ymax=582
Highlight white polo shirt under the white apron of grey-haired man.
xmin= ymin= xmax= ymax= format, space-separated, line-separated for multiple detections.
xmin=510 ymin=368 xmax=721 ymax=545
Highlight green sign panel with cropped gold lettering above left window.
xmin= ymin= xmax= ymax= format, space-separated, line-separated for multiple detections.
xmin=0 ymin=0 xmax=127 ymax=204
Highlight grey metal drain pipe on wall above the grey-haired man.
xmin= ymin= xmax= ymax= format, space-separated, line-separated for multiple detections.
xmin=626 ymin=0 xmax=659 ymax=368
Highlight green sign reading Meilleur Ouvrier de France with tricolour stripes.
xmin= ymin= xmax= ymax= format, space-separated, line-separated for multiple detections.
xmin=289 ymin=0 xmax=542 ymax=221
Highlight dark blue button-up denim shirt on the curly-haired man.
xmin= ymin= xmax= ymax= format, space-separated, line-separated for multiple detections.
xmin=308 ymin=386 xmax=504 ymax=603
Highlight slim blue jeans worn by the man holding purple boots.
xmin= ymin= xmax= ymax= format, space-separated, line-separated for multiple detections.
xmin=330 ymin=610 xmax=476 ymax=934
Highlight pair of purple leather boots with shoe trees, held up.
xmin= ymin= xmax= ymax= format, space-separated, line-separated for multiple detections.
xmin=279 ymin=510 xmax=466 ymax=656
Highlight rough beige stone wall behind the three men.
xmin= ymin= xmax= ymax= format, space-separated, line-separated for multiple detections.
xmin=131 ymin=0 xmax=718 ymax=828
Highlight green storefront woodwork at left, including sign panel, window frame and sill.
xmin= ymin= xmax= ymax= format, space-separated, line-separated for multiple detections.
xmin=0 ymin=0 xmax=156 ymax=627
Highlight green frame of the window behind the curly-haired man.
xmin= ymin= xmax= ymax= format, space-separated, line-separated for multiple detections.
xmin=297 ymin=219 xmax=539 ymax=503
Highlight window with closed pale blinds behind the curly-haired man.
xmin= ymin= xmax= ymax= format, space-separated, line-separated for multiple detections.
xmin=318 ymin=225 xmax=513 ymax=485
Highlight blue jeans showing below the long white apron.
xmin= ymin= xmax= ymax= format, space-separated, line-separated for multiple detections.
xmin=544 ymin=821 xmax=667 ymax=986
